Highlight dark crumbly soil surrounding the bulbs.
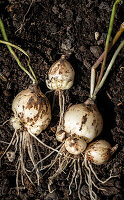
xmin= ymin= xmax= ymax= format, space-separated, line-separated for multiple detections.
xmin=0 ymin=0 xmax=124 ymax=200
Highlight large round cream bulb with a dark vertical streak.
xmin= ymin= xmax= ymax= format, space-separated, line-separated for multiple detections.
xmin=64 ymin=99 xmax=103 ymax=143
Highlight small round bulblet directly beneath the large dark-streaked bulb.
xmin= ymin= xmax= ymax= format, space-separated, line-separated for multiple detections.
xmin=65 ymin=137 xmax=87 ymax=155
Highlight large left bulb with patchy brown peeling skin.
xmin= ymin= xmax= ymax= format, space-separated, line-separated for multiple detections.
xmin=12 ymin=85 xmax=51 ymax=135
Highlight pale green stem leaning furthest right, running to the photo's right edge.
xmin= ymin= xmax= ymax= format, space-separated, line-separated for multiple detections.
xmin=92 ymin=40 xmax=124 ymax=100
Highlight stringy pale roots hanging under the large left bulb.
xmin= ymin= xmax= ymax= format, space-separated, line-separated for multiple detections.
xmin=0 ymin=130 xmax=48 ymax=195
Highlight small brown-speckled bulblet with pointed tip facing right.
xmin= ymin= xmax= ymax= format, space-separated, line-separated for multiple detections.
xmin=85 ymin=140 xmax=118 ymax=165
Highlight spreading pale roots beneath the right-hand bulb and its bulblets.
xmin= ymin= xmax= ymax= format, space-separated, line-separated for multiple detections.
xmin=45 ymin=144 xmax=117 ymax=200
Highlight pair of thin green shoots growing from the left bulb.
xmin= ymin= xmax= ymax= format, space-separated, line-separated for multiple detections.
xmin=0 ymin=19 xmax=37 ymax=84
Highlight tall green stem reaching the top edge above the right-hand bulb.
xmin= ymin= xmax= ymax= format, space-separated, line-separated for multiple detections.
xmin=97 ymin=0 xmax=123 ymax=86
